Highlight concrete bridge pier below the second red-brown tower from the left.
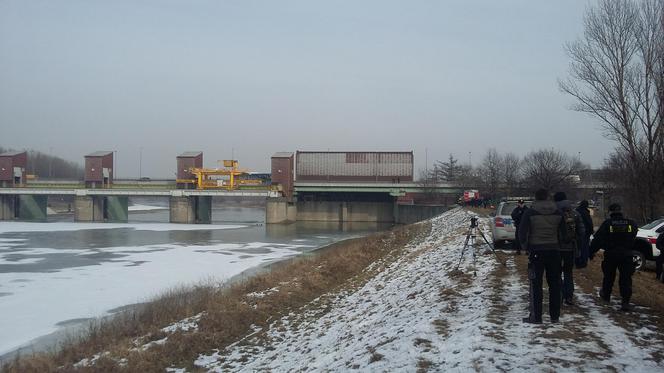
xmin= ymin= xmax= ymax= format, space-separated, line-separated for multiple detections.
xmin=74 ymin=195 xmax=129 ymax=223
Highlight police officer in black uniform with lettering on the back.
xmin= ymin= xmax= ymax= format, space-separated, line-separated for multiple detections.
xmin=590 ymin=203 xmax=638 ymax=311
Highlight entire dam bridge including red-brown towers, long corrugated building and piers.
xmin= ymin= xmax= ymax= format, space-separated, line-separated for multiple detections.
xmin=0 ymin=151 xmax=604 ymax=223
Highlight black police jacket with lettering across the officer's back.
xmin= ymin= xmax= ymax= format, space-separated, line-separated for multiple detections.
xmin=590 ymin=212 xmax=639 ymax=256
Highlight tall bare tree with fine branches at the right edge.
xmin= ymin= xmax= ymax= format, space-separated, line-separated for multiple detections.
xmin=560 ymin=0 xmax=664 ymax=218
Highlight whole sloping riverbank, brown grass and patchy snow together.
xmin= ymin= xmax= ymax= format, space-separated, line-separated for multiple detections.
xmin=5 ymin=208 xmax=664 ymax=372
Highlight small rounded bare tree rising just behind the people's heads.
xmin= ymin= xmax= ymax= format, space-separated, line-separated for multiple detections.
xmin=523 ymin=149 xmax=581 ymax=191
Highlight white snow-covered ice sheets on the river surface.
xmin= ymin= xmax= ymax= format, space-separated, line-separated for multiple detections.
xmin=0 ymin=222 xmax=309 ymax=356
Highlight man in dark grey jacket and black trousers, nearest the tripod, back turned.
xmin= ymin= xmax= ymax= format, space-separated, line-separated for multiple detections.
xmin=519 ymin=189 xmax=562 ymax=324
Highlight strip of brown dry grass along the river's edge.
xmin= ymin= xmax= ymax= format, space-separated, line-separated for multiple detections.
xmin=0 ymin=224 xmax=430 ymax=373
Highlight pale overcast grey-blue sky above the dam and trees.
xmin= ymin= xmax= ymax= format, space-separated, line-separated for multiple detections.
xmin=0 ymin=0 xmax=613 ymax=177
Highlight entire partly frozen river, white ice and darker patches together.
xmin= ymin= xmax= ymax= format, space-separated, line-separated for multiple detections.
xmin=0 ymin=201 xmax=387 ymax=356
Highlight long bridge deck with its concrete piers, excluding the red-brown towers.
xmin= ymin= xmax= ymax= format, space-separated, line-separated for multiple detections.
xmin=0 ymin=180 xmax=461 ymax=224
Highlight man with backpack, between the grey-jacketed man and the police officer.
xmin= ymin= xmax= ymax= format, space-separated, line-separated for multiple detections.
xmin=553 ymin=192 xmax=586 ymax=306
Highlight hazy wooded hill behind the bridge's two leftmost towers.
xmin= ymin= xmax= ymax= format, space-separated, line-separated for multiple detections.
xmin=0 ymin=146 xmax=84 ymax=180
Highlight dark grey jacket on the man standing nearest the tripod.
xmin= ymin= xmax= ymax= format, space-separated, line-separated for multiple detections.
xmin=519 ymin=201 xmax=562 ymax=251
